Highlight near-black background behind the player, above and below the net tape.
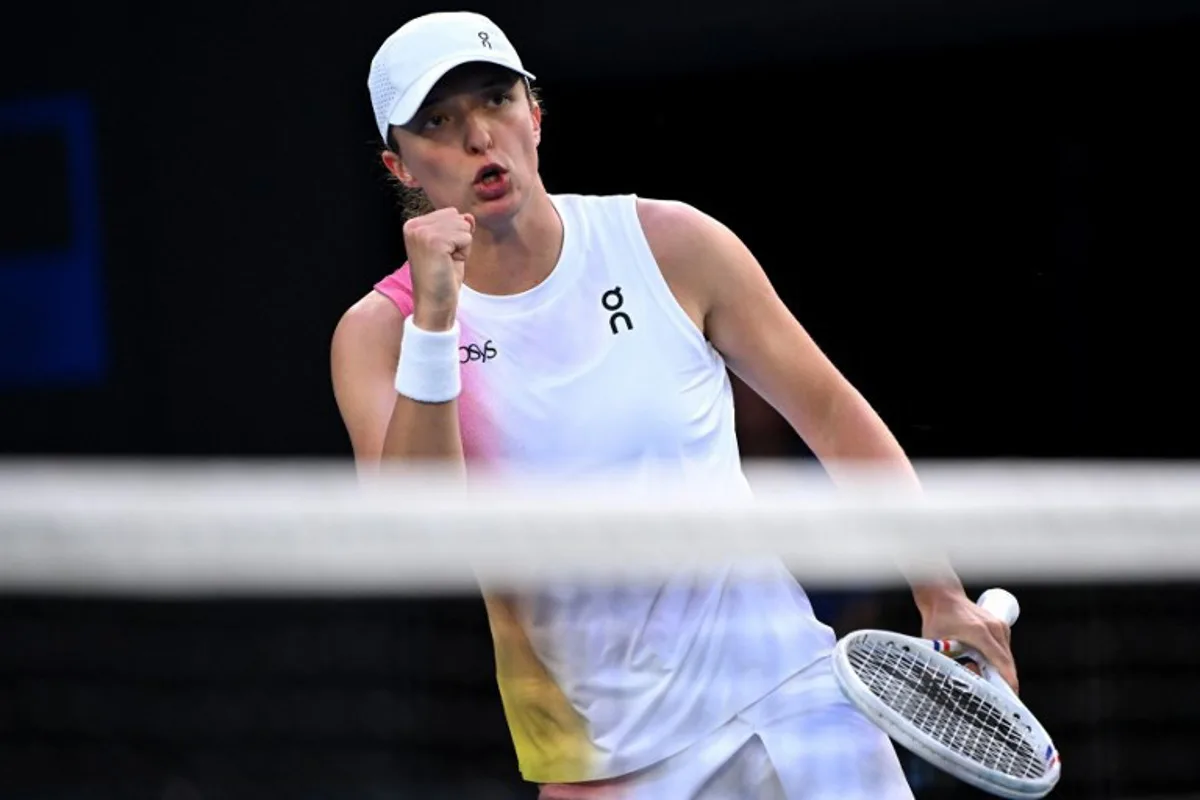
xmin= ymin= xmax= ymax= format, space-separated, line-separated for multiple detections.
xmin=0 ymin=0 xmax=1200 ymax=800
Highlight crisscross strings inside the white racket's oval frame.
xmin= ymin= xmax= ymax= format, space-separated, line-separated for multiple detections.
xmin=848 ymin=639 xmax=1045 ymax=778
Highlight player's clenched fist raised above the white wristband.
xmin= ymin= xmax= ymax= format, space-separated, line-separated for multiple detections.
xmin=404 ymin=209 xmax=475 ymax=331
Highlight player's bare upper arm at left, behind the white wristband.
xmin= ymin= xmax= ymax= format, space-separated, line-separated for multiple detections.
xmin=330 ymin=293 xmax=404 ymax=465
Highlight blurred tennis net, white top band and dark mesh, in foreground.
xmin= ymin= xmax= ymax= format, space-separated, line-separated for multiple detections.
xmin=0 ymin=463 xmax=1200 ymax=800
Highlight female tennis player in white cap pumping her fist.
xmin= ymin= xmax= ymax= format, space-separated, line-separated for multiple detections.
xmin=331 ymin=12 xmax=1015 ymax=800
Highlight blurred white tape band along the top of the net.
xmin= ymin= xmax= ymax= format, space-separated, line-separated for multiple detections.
xmin=0 ymin=462 xmax=1200 ymax=594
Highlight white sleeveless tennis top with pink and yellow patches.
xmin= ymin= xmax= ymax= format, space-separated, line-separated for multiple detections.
xmin=377 ymin=194 xmax=834 ymax=783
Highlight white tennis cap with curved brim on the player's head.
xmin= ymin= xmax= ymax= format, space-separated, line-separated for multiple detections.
xmin=367 ymin=11 xmax=534 ymax=142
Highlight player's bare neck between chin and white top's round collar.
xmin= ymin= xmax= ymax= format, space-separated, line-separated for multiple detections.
xmin=466 ymin=186 xmax=563 ymax=295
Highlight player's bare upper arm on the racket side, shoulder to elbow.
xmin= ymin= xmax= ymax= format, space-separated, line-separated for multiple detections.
xmin=638 ymin=200 xmax=854 ymax=445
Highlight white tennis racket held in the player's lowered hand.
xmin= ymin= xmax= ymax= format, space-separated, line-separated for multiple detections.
xmin=833 ymin=589 xmax=1061 ymax=798
